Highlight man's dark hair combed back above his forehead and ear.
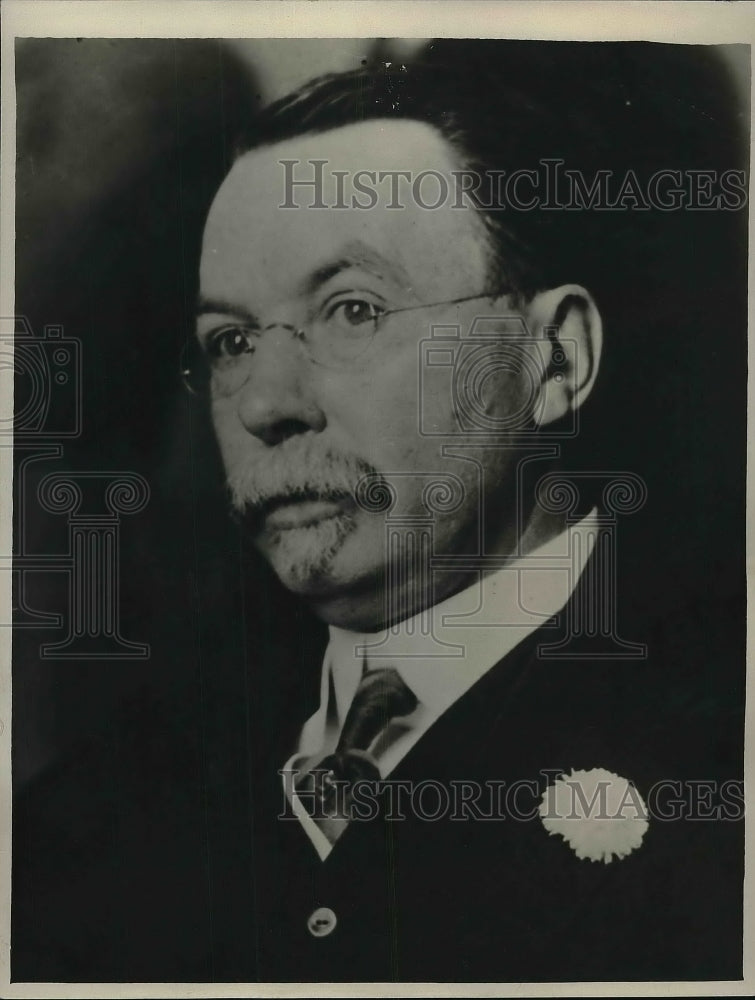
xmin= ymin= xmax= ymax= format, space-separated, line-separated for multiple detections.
xmin=236 ymin=42 xmax=616 ymax=298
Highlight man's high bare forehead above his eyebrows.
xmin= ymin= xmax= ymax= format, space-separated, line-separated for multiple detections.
xmin=201 ymin=121 xmax=489 ymax=298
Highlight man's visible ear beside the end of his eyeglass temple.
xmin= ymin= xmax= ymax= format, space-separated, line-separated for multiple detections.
xmin=527 ymin=285 xmax=603 ymax=427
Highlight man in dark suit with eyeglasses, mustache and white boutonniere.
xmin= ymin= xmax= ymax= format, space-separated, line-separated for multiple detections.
xmin=11 ymin=43 xmax=741 ymax=982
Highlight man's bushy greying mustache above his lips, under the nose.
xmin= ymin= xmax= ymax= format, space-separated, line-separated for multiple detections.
xmin=226 ymin=437 xmax=382 ymax=520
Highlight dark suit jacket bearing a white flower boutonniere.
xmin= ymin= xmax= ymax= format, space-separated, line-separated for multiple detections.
xmin=12 ymin=556 xmax=743 ymax=982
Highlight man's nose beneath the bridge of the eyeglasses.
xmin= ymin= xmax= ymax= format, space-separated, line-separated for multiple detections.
xmin=238 ymin=326 xmax=327 ymax=446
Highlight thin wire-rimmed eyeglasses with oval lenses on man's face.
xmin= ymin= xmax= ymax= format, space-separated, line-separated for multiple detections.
xmin=181 ymin=289 xmax=509 ymax=399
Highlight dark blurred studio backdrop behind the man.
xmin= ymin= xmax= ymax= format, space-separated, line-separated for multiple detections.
xmin=13 ymin=39 xmax=749 ymax=788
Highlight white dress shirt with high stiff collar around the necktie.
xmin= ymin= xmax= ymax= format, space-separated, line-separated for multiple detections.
xmin=283 ymin=510 xmax=598 ymax=860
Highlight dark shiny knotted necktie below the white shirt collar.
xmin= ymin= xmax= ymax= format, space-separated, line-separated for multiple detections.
xmin=296 ymin=667 xmax=418 ymax=842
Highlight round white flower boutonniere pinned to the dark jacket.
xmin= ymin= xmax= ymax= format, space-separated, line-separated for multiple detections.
xmin=540 ymin=767 xmax=648 ymax=864
